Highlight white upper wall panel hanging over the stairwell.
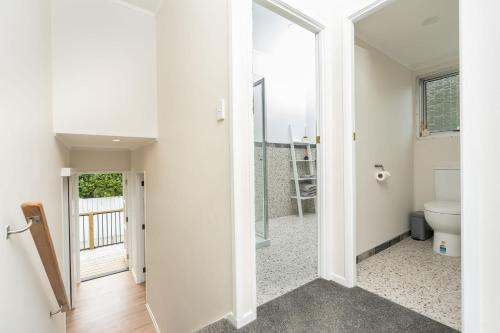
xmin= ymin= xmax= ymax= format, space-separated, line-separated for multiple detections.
xmin=52 ymin=0 xmax=157 ymax=138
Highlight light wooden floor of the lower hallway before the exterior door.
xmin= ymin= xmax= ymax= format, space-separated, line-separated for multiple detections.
xmin=66 ymin=271 xmax=155 ymax=333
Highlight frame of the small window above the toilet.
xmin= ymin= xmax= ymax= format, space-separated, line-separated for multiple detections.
xmin=418 ymin=68 xmax=460 ymax=138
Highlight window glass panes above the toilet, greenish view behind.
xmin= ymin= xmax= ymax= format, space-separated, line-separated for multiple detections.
xmin=420 ymin=72 xmax=460 ymax=136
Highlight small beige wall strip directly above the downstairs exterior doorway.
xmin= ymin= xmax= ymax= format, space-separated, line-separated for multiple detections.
xmin=70 ymin=149 xmax=131 ymax=172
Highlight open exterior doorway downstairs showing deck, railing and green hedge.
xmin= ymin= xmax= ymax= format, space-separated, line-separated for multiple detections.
xmin=78 ymin=173 xmax=129 ymax=282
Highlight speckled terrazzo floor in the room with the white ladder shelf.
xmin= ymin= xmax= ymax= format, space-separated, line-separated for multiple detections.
xmin=256 ymin=214 xmax=318 ymax=305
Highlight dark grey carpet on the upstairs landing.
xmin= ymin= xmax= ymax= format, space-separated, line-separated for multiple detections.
xmin=200 ymin=279 xmax=458 ymax=333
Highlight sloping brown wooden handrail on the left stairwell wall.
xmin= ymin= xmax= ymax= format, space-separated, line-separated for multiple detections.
xmin=21 ymin=202 xmax=70 ymax=312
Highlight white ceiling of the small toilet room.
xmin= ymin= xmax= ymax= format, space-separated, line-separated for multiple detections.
xmin=355 ymin=0 xmax=459 ymax=70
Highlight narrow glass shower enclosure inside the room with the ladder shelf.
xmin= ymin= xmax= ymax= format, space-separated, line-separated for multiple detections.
xmin=253 ymin=79 xmax=270 ymax=248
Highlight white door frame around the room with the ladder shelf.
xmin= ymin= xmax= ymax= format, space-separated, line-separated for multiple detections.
xmin=227 ymin=0 xmax=332 ymax=328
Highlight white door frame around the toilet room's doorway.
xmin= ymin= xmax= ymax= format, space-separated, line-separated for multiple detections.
xmin=342 ymin=0 xmax=470 ymax=331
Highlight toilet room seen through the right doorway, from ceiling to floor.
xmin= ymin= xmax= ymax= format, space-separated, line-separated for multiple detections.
xmin=354 ymin=0 xmax=461 ymax=330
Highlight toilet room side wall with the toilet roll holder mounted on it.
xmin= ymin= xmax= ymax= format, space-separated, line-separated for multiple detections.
xmin=355 ymin=41 xmax=414 ymax=254
